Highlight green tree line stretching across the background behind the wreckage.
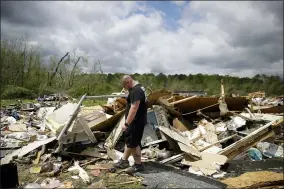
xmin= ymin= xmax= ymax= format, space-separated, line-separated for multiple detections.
xmin=0 ymin=37 xmax=284 ymax=99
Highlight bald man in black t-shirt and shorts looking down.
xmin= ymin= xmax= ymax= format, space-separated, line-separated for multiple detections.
xmin=114 ymin=75 xmax=147 ymax=173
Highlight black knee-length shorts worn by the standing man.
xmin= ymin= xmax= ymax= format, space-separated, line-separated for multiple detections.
xmin=125 ymin=121 xmax=146 ymax=148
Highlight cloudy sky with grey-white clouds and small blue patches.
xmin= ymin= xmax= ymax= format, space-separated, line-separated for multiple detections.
xmin=1 ymin=1 xmax=283 ymax=77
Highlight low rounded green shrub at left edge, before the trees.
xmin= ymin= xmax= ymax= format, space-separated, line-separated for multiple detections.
xmin=1 ymin=85 xmax=36 ymax=99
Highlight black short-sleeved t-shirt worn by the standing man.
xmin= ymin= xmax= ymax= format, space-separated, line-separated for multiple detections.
xmin=125 ymin=84 xmax=147 ymax=125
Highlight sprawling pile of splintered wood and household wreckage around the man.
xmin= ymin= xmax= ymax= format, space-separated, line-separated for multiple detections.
xmin=1 ymin=83 xmax=283 ymax=188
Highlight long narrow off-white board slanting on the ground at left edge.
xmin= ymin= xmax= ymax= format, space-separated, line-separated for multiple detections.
xmin=1 ymin=137 xmax=56 ymax=165
